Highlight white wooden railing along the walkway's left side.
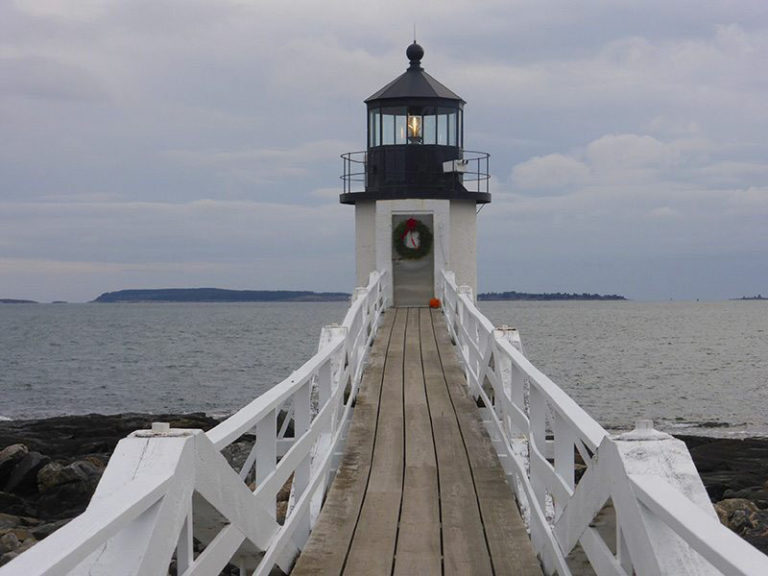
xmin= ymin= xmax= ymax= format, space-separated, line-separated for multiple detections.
xmin=0 ymin=272 xmax=387 ymax=576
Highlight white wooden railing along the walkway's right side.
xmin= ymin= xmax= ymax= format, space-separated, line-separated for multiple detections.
xmin=442 ymin=272 xmax=768 ymax=576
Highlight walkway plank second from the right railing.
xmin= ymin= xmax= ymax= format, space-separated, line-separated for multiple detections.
xmin=420 ymin=310 xmax=493 ymax=575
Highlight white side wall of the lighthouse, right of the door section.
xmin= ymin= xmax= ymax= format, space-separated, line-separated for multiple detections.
xmin=448 ymin=200 xmax=477 ymax=298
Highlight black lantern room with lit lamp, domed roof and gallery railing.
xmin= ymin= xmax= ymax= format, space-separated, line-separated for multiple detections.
xmin=341 ymin=41 xmax=490 ymax=204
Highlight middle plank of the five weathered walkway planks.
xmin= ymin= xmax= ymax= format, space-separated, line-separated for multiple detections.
xmin=394 ymin=309 xmax=442 ymax=576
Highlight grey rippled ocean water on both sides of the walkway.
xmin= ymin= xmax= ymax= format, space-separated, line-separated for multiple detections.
xmin=0 ymin=301 xmax=768 ymax=435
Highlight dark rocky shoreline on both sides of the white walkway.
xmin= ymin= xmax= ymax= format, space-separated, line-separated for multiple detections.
xmin=0 ymin=413 xmax=768 ymax=566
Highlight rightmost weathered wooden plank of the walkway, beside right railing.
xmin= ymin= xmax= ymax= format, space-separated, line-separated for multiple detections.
xmin=432 ymin=312 xmax=542 ymax=575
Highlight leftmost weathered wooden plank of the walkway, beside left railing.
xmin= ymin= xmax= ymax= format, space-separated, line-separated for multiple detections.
xmin=291 ymin=310 xmax=395 ymax=576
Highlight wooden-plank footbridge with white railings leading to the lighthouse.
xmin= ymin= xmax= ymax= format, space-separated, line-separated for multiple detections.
xmin=0 ymin=271 xmax=768 ymax=576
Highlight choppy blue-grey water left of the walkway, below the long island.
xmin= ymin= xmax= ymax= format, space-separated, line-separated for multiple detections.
xmin=0 ymin=302 xmax=347 ymax=418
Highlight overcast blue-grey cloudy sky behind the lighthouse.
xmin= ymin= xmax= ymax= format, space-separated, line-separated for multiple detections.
xmin=0 ymin=0 xmax=768 ymax=301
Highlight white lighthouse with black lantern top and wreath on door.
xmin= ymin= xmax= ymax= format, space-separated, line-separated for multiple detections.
xmin=340 ymin=41 xmax=491 ymax=306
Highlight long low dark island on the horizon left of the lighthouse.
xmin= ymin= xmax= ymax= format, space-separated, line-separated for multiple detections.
xmin=94 ymin=288 xmax=350 ymax=303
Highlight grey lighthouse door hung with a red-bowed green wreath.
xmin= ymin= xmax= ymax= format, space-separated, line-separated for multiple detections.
xmin=392 ymin=214 xmax=435 ymax=306
